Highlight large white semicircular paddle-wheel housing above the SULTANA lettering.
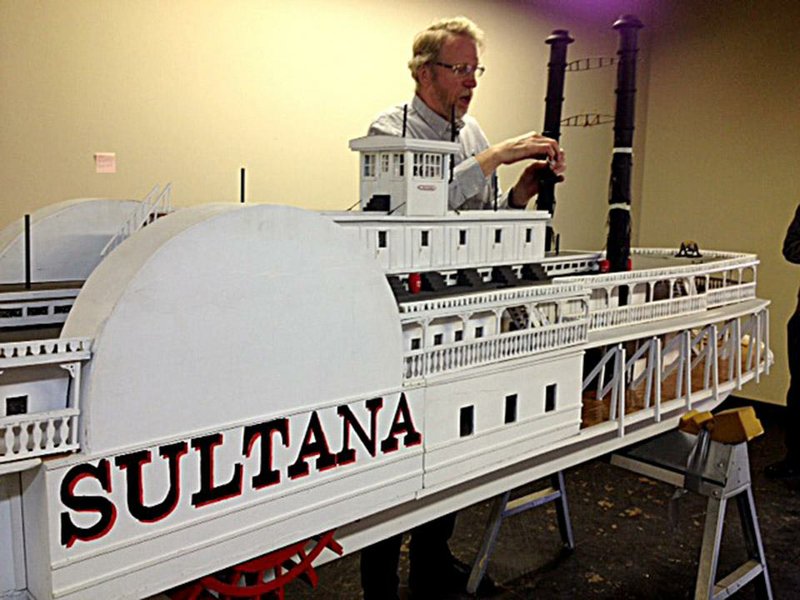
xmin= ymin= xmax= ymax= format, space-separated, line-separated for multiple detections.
xmin=63 ymin=205 xmax=402 ymax=453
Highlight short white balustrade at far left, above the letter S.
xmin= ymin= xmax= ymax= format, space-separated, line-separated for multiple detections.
xmin=0 ymin=408 xmax=80 ymax=463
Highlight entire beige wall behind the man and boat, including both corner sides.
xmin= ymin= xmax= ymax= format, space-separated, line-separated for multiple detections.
xmin=0 ymin=0 xmax=800 ymax=401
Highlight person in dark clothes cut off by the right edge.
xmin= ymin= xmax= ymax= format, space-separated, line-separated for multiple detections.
xmin=766 ymin=206 xmax=800 ymax=479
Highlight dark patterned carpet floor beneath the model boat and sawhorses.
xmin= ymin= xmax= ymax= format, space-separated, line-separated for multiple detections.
xmin=286 ymin=399 xmax=800 ymax=600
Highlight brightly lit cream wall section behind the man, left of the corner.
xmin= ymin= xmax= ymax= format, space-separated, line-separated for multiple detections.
xmin=0 ymin=0 xmax=652 ymax=248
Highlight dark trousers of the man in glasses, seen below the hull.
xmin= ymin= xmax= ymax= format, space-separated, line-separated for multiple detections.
xmin=361 ymin=513 xmax=456 ymax=600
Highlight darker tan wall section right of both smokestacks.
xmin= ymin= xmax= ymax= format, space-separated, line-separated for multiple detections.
xmin=637 ymin=0 xmax=800 ymax=404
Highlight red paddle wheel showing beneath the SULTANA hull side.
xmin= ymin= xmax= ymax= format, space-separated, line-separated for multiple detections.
xmin=168 ymin=531 xmax=343 ymax=600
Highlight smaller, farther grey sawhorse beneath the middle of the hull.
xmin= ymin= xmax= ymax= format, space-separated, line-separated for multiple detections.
xmin=467 ymin=471 xmax=575 ymax=594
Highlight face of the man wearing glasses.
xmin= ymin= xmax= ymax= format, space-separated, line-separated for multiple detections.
xmin=422 ymin=35 xmax=478 ymax=119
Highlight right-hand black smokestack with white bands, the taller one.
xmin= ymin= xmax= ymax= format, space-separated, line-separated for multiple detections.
xmin=606 ymin=15 xmax=643 ymax=282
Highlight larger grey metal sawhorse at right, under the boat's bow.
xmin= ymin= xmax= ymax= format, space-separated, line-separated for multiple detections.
xmin=611 ymin=430 xmax=772 ymax=600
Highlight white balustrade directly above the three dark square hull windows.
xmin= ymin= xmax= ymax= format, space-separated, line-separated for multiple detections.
xmin=405 ymin=321 xmax=588 ymax=379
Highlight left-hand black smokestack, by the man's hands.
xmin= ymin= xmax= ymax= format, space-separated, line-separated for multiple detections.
xmin=536 ymin=29 xmax=575 ymax=252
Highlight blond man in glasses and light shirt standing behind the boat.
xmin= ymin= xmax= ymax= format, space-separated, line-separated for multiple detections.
xmin=361 ymin=17 xmax=565 ymax=600
